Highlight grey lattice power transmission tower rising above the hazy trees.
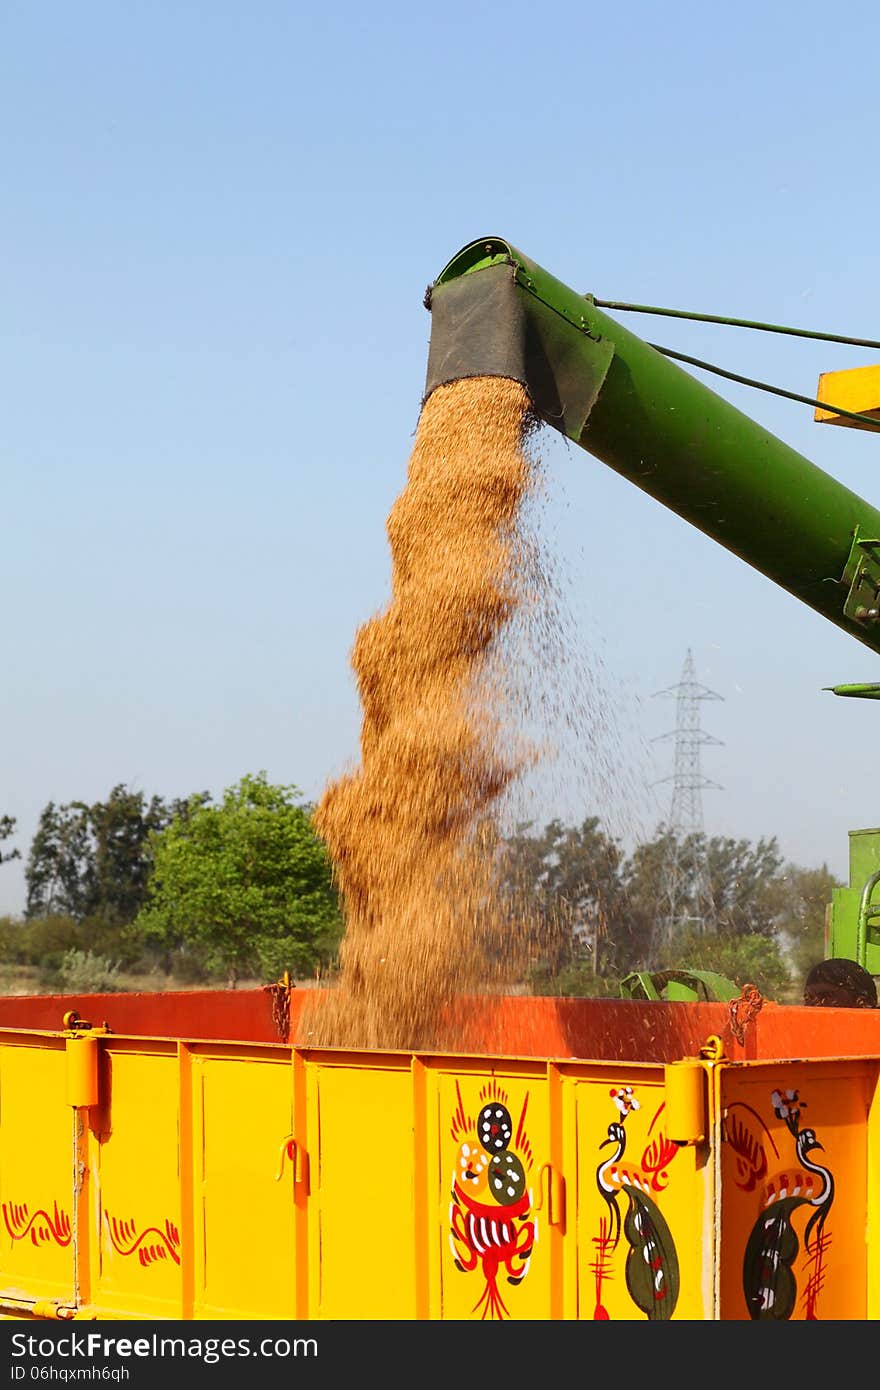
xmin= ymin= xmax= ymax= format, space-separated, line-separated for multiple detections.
xmin=653 ymin=648 xmax=724 ymax=944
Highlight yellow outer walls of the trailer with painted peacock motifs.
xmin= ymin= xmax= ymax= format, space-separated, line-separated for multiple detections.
xmin=0 ymin=1011 xmax=880 ymax=1322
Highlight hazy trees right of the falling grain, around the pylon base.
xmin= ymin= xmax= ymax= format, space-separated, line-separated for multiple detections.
xmin=505 ymin=817 xmax=834 ymax=998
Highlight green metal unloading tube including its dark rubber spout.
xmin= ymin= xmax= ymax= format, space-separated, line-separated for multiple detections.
xmin=425 ymin=236 xmax=880 ymax=652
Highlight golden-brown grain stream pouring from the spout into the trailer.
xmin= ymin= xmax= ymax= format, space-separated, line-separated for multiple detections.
xmin=300 ymin=378 xmax=534 ymax=1049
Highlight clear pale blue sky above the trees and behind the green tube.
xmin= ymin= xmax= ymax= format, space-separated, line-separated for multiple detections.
xmin=0 ymin=0 xmax=880 ymax=912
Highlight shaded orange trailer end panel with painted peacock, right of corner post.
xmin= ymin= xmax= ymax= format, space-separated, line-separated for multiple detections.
xmin=720 ymin=1059 xmax=877 ymax=1322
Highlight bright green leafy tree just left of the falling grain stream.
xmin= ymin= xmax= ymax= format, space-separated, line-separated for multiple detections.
xmin=132 ymin=773 xmax=342 ymax=986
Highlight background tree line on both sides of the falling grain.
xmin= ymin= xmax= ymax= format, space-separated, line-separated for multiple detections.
xmin=8 ymin=773 xmax=838 ymax=998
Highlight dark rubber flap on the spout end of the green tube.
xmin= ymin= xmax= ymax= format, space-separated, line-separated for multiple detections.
xmin=424 ymin=264 xmax=614 ymax=441
